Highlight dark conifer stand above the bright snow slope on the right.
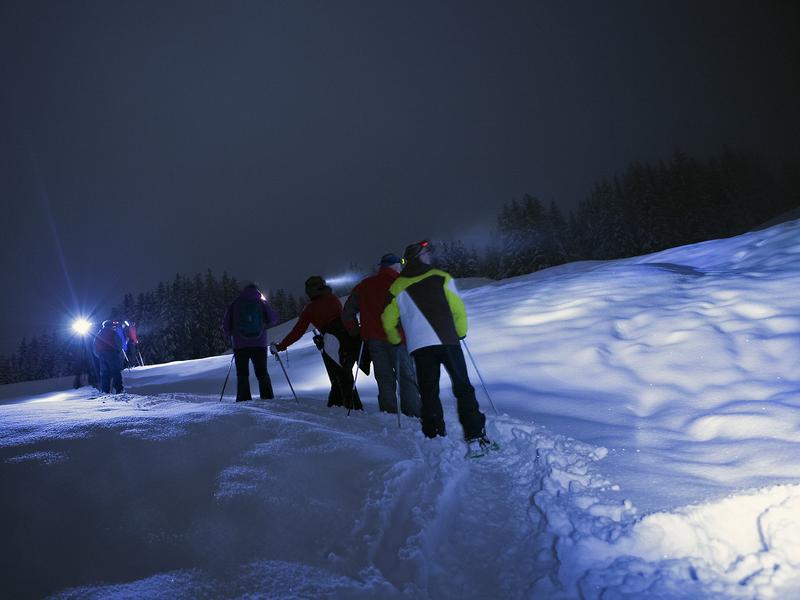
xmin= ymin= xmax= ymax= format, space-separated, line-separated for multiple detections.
xmin=437 ymin=151 xmax=800 ymax=279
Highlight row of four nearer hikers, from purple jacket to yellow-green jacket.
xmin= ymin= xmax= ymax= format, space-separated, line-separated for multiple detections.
xmin=222 ymin=241 xmax=492 ymax=453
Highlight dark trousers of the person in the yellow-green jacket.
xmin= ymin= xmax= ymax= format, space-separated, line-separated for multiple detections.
xmin=411 ymin=344 xmax=486 ymax=440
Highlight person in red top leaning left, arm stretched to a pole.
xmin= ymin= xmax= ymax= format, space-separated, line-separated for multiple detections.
xmin=272 ymin=275 xmax=363 ymax=410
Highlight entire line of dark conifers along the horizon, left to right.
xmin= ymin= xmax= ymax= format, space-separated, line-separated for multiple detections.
xmin=0 ymin=151 xmax=800 ymax=384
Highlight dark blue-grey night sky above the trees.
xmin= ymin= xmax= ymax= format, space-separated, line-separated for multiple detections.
xmin=0 ymin=0 xmax=800 ymax=352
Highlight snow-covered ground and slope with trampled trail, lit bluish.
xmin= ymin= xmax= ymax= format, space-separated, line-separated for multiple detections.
xmin=0 ymin=221 xmax=800 ymax=599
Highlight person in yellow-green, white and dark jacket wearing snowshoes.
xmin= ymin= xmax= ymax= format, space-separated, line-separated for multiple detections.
xmin=381 ymin=241 xmax=491 ymax=450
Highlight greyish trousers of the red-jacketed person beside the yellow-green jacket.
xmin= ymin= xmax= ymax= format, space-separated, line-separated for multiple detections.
xmin=367 ymin=340 xmax=421 ymax=417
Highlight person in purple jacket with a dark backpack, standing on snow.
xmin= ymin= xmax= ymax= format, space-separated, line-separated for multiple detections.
xmin=222 ymin=283 xmax=278 ymax=402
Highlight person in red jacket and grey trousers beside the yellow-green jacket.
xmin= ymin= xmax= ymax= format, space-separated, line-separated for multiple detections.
xmin=342 ymin=254 xmax=421 ymax=417
